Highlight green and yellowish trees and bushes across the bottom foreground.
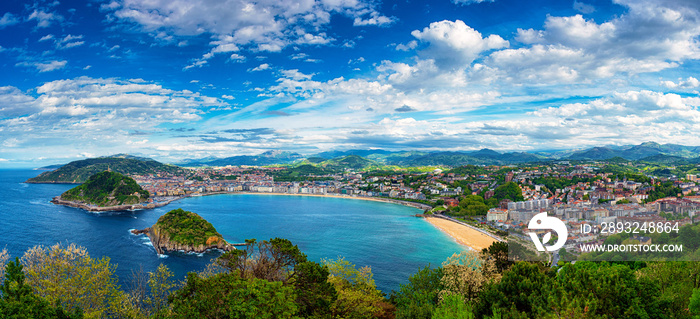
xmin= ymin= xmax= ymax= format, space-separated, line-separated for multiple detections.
xmin=0 ymin=242 xmax=700 ymax=319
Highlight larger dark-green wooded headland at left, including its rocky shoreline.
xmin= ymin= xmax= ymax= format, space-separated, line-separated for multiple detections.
xmin=52 ymin=171 xmax=155 ymax=211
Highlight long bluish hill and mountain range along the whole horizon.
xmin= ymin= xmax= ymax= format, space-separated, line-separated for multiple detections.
xmin=27 ymin=142 xmax=700 ymax=183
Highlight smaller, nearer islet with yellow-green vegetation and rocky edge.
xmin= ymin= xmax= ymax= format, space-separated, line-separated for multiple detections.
xmin=132 ymin=208 xmax=235 ymax=254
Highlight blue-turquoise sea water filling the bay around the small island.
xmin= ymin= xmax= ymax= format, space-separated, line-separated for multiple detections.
xmin=0 ymin=169 xmax=465 ymax=294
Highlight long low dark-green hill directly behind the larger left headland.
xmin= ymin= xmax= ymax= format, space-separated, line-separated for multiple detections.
xmin=27 ymin=157 xmax=184 ymax=183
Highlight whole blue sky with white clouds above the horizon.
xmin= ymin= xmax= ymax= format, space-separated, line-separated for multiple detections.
xmin=0 ymin=0 xmax=700 ymax=167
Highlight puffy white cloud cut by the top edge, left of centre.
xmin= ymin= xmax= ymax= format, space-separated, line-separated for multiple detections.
xmin=101 ymin=0 xmax=395 ymax=65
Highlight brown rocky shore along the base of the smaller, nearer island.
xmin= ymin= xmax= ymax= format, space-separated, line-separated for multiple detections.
xmin=131 ymin=226 xmax=236 ymax=255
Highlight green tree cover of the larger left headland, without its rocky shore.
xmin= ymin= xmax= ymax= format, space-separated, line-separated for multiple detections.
xmin=61 ymin=171 xmax=149 ymax=207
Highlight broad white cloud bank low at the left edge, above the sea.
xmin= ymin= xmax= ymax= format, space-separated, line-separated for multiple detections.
xmin=0 ymin=77 xmax=228 ymax=160
